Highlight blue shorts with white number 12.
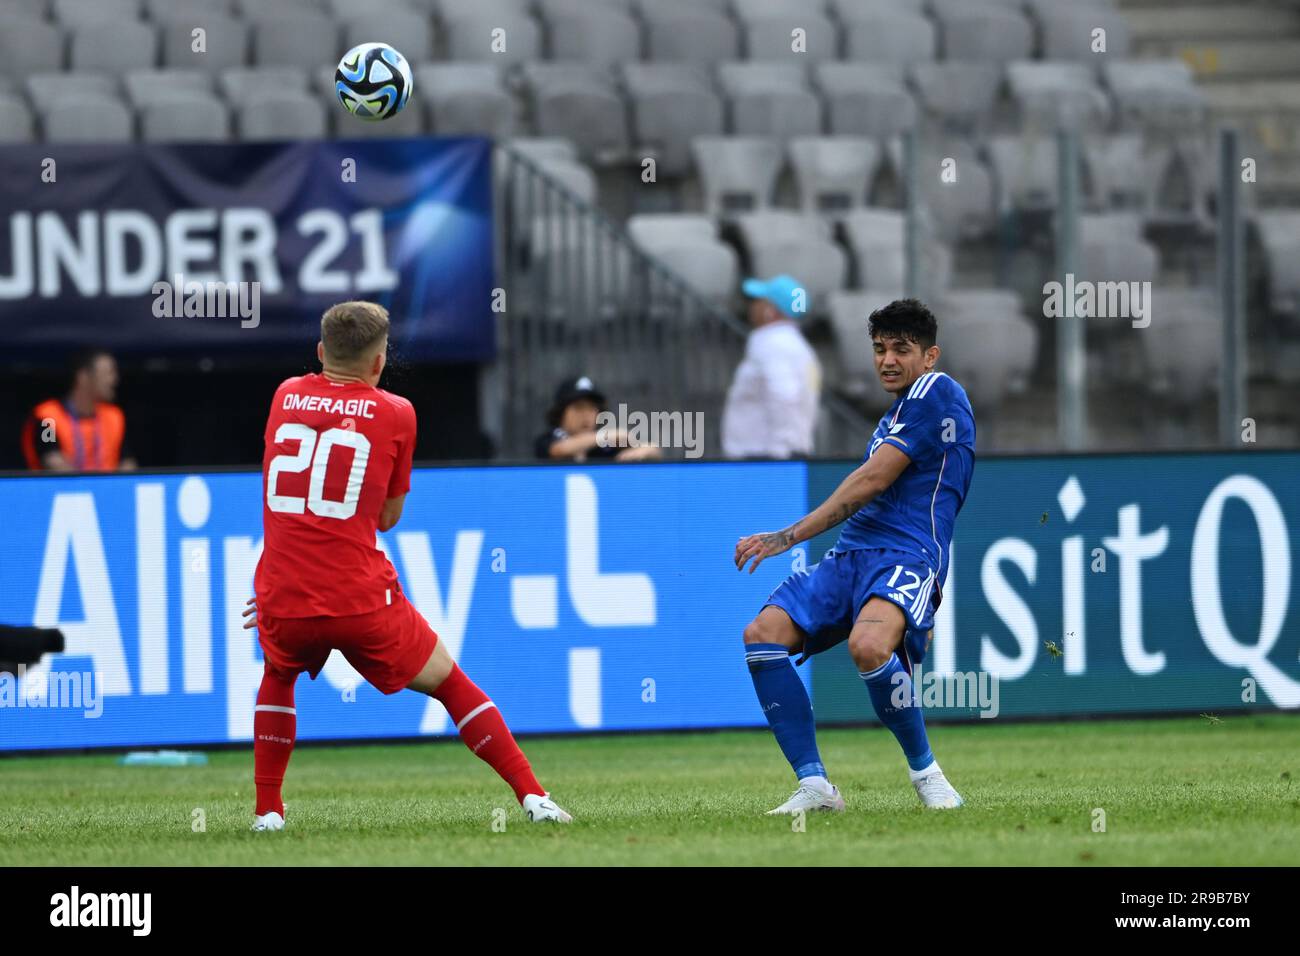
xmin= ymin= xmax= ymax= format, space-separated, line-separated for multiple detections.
xmin=763 ymin=549 xmax=939 ymax=671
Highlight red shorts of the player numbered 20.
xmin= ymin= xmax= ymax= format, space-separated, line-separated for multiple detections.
xmin=257 ymin=588 xmax=438 ymax=693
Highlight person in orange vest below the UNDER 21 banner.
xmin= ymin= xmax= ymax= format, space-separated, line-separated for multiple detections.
xmin=22 ymin=349 xmax=135 ymax=471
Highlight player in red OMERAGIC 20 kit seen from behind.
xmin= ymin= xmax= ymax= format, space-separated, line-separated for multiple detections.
xmin=244 ymin=302 xmax=571 ymax=830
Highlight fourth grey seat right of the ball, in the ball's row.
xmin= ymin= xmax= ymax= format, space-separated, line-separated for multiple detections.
xmin=718 ymin=62 xmax=822 ymax=138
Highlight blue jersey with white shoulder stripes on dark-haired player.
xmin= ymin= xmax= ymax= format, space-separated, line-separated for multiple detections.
xmin=833 ymin=372 xmax=975 ymax=581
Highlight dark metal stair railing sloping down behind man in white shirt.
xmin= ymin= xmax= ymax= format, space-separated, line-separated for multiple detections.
xmin=486 ymin=146 xmax=872 ymax=458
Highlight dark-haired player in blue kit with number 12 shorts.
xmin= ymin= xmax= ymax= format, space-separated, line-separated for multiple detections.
xmin=736 ymin=299 xmax=975 ymax=813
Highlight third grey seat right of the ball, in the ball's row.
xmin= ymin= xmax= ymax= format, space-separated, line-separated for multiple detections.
xmin=623 ymin=62 xmax=725 ymax=176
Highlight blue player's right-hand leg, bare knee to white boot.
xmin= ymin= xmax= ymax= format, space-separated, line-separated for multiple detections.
xmin=849 ymin=597 xmax=962 ymax=809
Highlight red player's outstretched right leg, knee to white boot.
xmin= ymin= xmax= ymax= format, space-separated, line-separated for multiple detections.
xmin=410 ymin=641 xmax=573 ymax=823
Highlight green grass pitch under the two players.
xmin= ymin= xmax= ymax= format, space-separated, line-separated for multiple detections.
xmin=0 ymin=714 xmax=1300 ymax=866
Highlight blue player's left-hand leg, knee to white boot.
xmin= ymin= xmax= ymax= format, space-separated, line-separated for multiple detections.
xmin=744 ymin=605 xmax=844 ymax=814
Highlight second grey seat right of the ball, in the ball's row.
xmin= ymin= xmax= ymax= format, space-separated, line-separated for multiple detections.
xmin=525 ymin=64 xmax=628 ymax=163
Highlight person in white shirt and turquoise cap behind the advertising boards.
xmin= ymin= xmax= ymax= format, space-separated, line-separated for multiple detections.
xmin=723 ymin=276 xmax=822 ymax=458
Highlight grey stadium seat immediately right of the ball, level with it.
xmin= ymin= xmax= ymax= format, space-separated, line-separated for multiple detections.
xmin=418 ymin=62 xmax=519 ymax=139
